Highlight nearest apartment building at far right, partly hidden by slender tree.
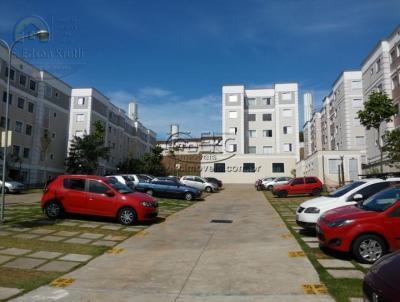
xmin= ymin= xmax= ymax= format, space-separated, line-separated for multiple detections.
xmin=361 ymin=26 xmax=400 ymax=171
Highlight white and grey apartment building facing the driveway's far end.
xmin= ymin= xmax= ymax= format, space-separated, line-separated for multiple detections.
xmin=202 ymin=83 xmax=300 ymax=183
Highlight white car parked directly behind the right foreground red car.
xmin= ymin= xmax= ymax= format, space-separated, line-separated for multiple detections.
xmin=296 ymin=178 xmax=400 ymax=229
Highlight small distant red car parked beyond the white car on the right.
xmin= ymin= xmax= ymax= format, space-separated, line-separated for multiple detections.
xmin=272 ymin=176 xmax=323 ymax=197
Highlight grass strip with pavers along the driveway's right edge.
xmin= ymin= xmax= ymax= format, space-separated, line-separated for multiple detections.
xmin=264 ymin=192 xmax=367 ymax=302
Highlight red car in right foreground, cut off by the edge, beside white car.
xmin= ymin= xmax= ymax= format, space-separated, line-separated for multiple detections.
xmin=317 ymin=186 xmax=400 ymax=263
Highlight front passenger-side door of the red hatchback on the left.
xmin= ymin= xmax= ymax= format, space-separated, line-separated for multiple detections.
xmin=87 ymin=179 xmax=117 ymax=216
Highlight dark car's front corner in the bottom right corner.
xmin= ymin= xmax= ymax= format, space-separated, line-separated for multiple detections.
xmin=363 ymin=252 xmax=400 ymax=302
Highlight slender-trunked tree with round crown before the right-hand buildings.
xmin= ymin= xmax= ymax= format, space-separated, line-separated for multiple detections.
xmin=358 ymin=92 xmax=397 ymax=173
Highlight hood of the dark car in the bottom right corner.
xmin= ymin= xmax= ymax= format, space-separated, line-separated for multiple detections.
xmin=370 ymin=252 xmax=400 ymax=295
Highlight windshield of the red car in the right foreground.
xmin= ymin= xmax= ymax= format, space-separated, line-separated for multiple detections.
xmin=359 ymin=187 xmax=400 ymax=212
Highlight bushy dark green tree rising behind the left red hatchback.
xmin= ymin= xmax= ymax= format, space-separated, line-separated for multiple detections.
xmin=66 ymin=121 xmax=110 ymax=174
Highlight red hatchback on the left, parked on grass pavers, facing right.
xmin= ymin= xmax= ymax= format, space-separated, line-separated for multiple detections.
xmin=41 ymin=175 xmax=158 ymax=225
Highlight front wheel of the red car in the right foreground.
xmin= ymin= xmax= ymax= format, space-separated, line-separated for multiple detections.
xmin=352 ymin=234 xmax=387 ymax=264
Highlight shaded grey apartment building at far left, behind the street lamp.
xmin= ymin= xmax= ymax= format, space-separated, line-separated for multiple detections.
xmin=0 ymin=45 xmax=71 ymax=185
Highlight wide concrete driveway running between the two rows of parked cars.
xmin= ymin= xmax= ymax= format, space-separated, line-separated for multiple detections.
xmin=12 ymin=185 xmax=333 ymax=302
